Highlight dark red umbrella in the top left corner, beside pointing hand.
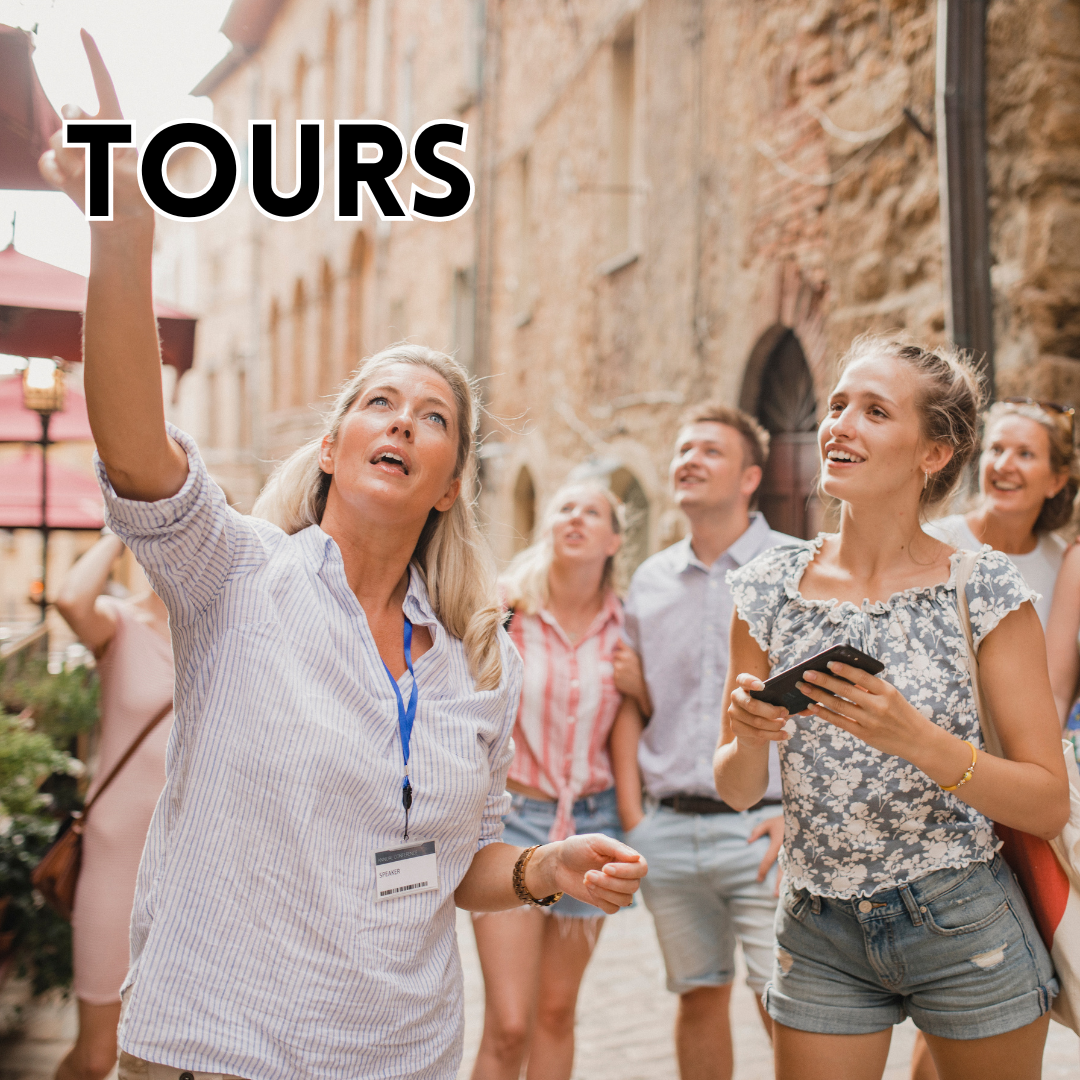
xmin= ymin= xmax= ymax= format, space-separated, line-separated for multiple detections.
xmin=0 ymin=25 xmax=60 ymax=190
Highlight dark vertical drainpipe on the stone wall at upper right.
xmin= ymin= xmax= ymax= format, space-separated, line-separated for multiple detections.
xmin=936 ymin=0 xmax=994 ymax=395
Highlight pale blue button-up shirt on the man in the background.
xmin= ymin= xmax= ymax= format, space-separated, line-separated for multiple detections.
xmin=625 ymin=511 xmax=792 ymax=799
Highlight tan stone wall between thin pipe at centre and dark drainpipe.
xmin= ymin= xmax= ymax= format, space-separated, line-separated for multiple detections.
xmin=477 ymin=0 xmax=944 ymax=554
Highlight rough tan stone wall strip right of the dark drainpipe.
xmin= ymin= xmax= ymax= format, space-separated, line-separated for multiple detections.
xmin=987 ymin=0 xmax=1080 ymax=405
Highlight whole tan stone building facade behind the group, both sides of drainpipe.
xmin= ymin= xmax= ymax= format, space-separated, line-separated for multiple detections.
xmin=158 ymin=0 xmax=1080 ymax=558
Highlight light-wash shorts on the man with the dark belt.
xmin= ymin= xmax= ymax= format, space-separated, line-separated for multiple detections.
xmin=624 ymin=807 xmax=780 ymax=995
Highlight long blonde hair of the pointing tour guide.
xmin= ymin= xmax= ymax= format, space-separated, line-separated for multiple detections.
xmin=252 ymin=343 xmax=502 ymax=690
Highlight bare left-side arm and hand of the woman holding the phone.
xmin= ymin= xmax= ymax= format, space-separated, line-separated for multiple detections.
xmin=713 ymin=611 xmax=788 ymax=810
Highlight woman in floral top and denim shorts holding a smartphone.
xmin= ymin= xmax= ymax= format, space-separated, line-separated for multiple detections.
xmin=715 ymin=337 xmax=1068 ymax=1080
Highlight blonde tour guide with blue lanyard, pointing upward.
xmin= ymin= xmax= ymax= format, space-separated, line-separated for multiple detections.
xmin=41 ymin=36 xmax=645 ymax=1080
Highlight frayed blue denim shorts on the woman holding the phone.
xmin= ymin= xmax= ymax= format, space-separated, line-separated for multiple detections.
xmin=765 ymin=855 xmax=1058 ymax=1039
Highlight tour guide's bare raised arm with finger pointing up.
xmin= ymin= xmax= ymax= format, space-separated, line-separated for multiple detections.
xmin=40 ymin=30 xmax=188 ymax=502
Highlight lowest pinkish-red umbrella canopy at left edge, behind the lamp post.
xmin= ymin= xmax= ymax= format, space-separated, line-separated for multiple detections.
xmin=0 ymin=450 xmax=105 ymax=529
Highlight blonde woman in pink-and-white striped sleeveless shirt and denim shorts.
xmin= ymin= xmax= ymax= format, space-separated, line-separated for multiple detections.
xmin=472 ymin=483 xmax=640 ymax=1080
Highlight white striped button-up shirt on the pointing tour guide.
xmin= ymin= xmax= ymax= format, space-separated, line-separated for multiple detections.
xmin=97 ymin=428 xmax=522 ymax=1080
